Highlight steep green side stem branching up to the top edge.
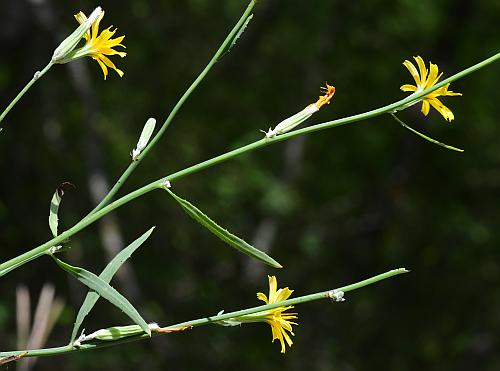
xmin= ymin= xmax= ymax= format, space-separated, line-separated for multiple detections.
xmin=89 ymin=0 xmax=255 ymax=215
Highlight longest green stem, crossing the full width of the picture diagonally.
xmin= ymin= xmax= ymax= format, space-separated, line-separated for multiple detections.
xmin=0 ymin=53 xmax=500 ymax=277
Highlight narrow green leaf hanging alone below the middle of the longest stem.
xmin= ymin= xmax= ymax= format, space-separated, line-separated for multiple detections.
xmin=165 ymin=188 xmax=283 ymax=268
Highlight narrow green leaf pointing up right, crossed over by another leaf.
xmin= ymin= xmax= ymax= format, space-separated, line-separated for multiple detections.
xmin=71 ymin=227 xmax=155 ymax=344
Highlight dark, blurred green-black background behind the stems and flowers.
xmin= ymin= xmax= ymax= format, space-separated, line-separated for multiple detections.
xmin=0 ymin=0 xmax=500 ymax=370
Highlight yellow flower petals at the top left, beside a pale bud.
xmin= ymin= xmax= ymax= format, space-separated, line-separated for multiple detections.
xmin=73 ymin=11 xmax=127 ymax=80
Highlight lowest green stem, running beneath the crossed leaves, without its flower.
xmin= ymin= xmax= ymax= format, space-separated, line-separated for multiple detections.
xmin=0 ymin=268 xmax=408 ymax=361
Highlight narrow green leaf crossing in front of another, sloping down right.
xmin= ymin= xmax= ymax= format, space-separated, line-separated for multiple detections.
xmin=52 ymin=256 xmax=151 ymax=336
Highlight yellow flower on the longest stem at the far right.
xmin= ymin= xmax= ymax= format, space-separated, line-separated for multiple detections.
xmin=400 ymin=56 xmax=462 ymax=122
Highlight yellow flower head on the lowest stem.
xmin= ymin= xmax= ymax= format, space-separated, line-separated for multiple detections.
xmin=257 ymin=276 xmax=298 ymax=353
